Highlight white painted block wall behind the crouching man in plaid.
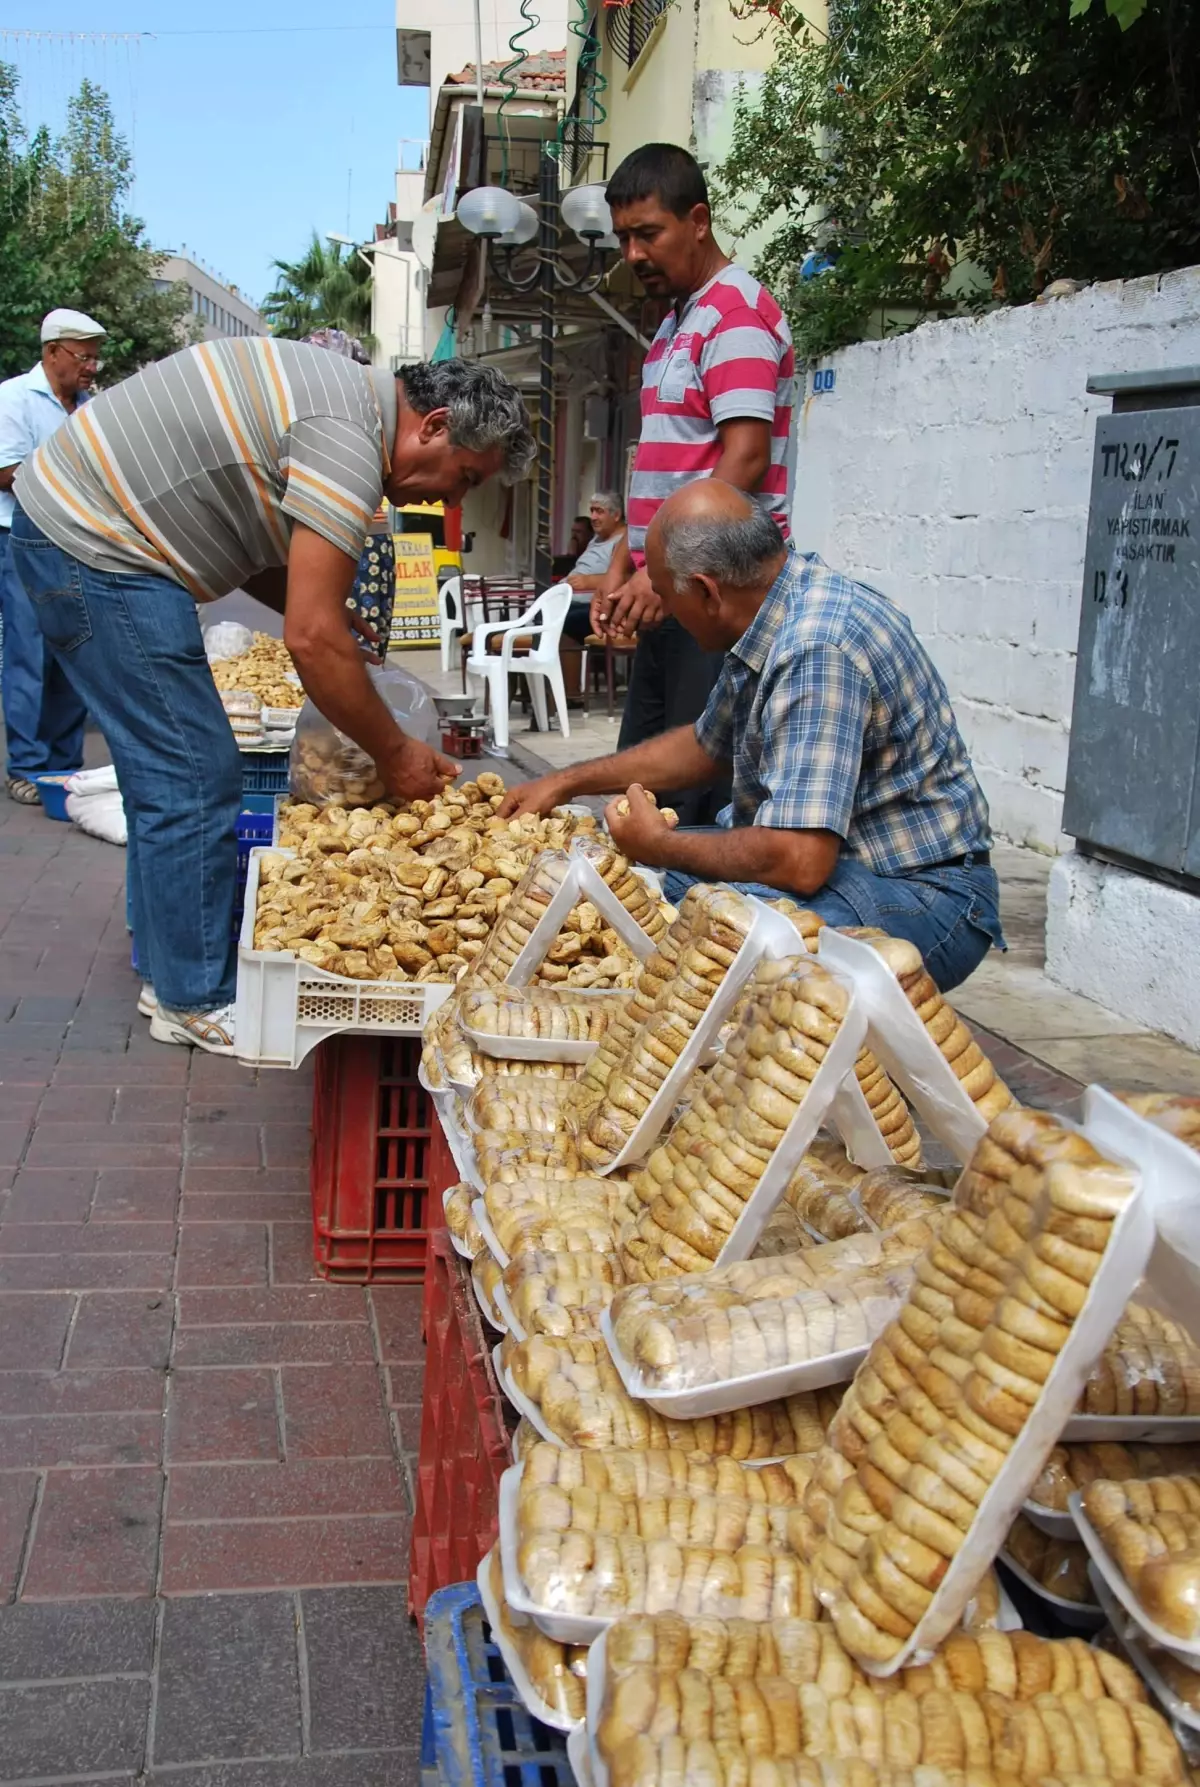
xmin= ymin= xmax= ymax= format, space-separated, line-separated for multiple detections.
xmin=793 ymin=268 xmax=1200 ymax=851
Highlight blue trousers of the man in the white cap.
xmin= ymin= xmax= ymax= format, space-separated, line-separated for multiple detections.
xmin=0 ymin=527 xmax=88 ymax=781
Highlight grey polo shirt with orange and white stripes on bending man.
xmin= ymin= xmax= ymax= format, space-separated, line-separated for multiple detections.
xmin=14 ymin=336 xmax=396 ymax=602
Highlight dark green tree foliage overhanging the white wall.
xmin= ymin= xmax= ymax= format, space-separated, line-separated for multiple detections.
xmin=713 ymin=0 xmax=1200 ymax=356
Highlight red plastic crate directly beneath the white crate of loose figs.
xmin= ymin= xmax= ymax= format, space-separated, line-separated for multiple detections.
xmin=311 ymin=1036 xmax=457 ymax=1285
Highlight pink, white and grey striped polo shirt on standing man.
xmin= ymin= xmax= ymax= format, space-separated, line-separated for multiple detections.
xmin=629 ymin=266 xmax=796 ymax=565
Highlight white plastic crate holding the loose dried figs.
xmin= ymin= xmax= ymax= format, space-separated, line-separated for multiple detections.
xmin=234 ymin=851 xmax=454 ymax=1067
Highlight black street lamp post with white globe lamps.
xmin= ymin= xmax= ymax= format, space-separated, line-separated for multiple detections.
xmin=457 ymin=150 xmax=616 ymax=590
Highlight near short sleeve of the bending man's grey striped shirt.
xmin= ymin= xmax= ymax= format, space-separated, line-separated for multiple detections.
xmin=280 ymin=416 xmax=384 ymax=563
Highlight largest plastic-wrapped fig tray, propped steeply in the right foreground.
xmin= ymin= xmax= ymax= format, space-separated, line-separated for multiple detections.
xmin=805 ymin=1110 xmax=1154 ymax=1674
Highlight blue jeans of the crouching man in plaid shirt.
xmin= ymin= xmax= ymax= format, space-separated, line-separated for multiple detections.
xmin=664 ymin=826 xmax=1005 ymax=994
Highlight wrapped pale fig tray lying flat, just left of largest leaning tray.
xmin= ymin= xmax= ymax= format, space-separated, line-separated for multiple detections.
xmin=604 ymin=1222 xmax=932 ymax=1415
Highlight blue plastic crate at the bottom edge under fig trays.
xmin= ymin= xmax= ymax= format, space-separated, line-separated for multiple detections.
xmin=421 ymin=1581 xmax=575 ymax=1787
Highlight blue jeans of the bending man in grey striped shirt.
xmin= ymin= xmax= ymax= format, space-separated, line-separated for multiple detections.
xmin=13 ymin=508 xmax=241 ymax=1011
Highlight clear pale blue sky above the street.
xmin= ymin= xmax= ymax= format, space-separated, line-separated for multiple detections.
xmin=0 ymin=0 xmax=429 ymax=300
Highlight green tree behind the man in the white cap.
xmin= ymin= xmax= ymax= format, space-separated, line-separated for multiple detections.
xmin=0 ymin=63 xmax=188 ymax=384
